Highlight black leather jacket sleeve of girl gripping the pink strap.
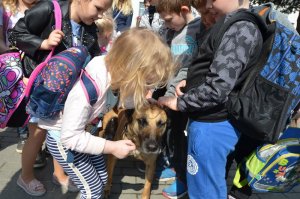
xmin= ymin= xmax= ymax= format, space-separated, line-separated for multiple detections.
xmin=8 ymin=1 xmax=54 ymax=57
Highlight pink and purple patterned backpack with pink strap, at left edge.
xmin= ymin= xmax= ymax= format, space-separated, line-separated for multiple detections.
xmin=0 ymin=0 xmax=62 ymax=128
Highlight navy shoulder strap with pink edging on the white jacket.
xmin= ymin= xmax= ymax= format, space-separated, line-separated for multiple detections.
xmin=80 ymin=69 xmax=100 ymax=106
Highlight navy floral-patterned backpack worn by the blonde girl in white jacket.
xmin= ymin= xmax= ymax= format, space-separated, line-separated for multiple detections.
xmin=26 ymin=46 xmax=99 ymax=119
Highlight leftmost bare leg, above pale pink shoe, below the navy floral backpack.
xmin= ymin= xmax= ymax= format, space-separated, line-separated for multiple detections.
xmin=21 ymin=123 xmax=46 ymax=183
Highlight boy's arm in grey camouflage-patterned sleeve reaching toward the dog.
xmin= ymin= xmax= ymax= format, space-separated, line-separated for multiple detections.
xmin=177 ymin=21 xmax=262 ymax=112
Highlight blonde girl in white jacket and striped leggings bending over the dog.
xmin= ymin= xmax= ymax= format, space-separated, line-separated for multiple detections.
xmin=39 ymin=28 xmax=174 ymax=198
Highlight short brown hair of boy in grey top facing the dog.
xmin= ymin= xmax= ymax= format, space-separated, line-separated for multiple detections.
xmin=156 ymin=0 xmax=192 ymax=15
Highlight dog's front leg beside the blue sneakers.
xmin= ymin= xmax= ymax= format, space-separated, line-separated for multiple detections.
xmin=142 ymin=158 xmax=156 ymax=199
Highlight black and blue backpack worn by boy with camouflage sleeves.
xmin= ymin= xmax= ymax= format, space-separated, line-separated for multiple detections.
xmin=214 ymin=10 xmax=300 ymax=143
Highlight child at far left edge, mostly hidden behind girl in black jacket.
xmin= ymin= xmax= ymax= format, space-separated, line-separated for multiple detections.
xmin=0 ymin=0 xmax=38 ymax=154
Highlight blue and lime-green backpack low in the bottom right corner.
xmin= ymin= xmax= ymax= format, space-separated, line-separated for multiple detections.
xmin=233 ymin=128 xmax=300 ymax=192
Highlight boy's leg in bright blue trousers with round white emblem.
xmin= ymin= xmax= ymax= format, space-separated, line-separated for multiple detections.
xmin=187 ymin=121 xmax=239 ymax=199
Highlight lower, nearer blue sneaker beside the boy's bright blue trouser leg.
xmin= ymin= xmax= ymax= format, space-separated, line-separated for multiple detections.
xmin=162 ymin=179 xmax=187 ymax=199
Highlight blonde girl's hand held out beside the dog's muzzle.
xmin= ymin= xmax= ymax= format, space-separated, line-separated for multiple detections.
xmin=103 ymin=140 xmax=136 ymax=159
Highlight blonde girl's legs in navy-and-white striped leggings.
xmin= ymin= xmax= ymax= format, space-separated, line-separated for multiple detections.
xmin=46 ymin=134 xmax=107 ymax=198
